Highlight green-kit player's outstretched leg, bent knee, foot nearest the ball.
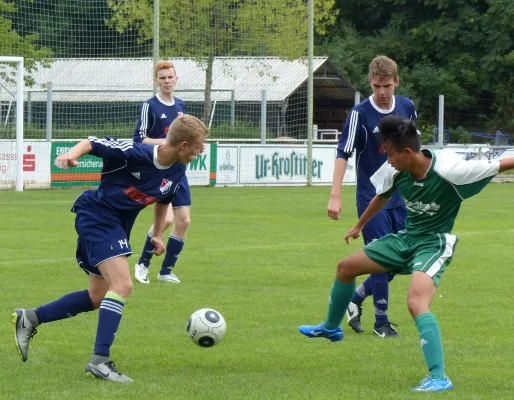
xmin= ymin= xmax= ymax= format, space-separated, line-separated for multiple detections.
xmin=298 ymin=250 xmax=387 ymax=342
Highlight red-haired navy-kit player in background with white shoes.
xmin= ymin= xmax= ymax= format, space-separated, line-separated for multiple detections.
xmin=134 ymin=61 xmax=191 ymax=283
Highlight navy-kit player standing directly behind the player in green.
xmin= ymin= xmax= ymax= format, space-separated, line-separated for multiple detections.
xmin=328 ymin=56 xmax=416 ymax=337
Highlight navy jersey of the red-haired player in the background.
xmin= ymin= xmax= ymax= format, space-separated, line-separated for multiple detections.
xmin=134 ymin=96 xmax=186 ymax=143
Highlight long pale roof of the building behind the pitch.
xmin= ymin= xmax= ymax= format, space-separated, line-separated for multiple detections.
xmin=0 ymin=57 xmax=353 ymax=102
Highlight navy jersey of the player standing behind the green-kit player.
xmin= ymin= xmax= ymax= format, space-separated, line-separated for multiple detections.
xmin=337 ymin=96 xmax=417 ymax=209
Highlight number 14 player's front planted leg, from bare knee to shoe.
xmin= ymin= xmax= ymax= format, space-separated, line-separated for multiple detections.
xmin=86 ymin=255 xmax=133 ymax=383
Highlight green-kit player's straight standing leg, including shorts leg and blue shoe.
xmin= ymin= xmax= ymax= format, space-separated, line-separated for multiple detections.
xmin=407 ymin=234 xmax=457 ymax=392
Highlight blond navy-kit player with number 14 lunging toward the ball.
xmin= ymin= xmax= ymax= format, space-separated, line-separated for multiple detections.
xmin=11 ymin=115 xmax=209 ymax=382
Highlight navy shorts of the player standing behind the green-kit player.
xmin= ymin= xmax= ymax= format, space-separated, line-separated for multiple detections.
xmin=357 ymin=205 xmax=407 ymax=244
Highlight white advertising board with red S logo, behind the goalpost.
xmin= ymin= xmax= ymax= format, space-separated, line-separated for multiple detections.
xmin=0 ymin=140 xmax=52 ymax=189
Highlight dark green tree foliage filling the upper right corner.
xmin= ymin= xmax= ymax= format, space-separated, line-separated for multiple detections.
xmin=317 ymin=0 xmax=514 ymax=131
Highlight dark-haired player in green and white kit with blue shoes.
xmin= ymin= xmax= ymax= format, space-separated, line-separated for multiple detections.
xmin=298 ymin=116 xmax=514 ymax=392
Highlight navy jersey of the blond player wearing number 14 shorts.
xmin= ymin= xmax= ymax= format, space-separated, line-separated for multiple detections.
xmin=72 ymin=136 xmax=186 ymax=228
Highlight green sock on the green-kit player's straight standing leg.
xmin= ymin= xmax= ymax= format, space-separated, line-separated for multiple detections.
xmin=414 ymin=313 xmax=446 ymax=379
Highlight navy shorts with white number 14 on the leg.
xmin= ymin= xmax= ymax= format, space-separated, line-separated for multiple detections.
xmin=75 ymin=213 xmax=133 ymax=276
